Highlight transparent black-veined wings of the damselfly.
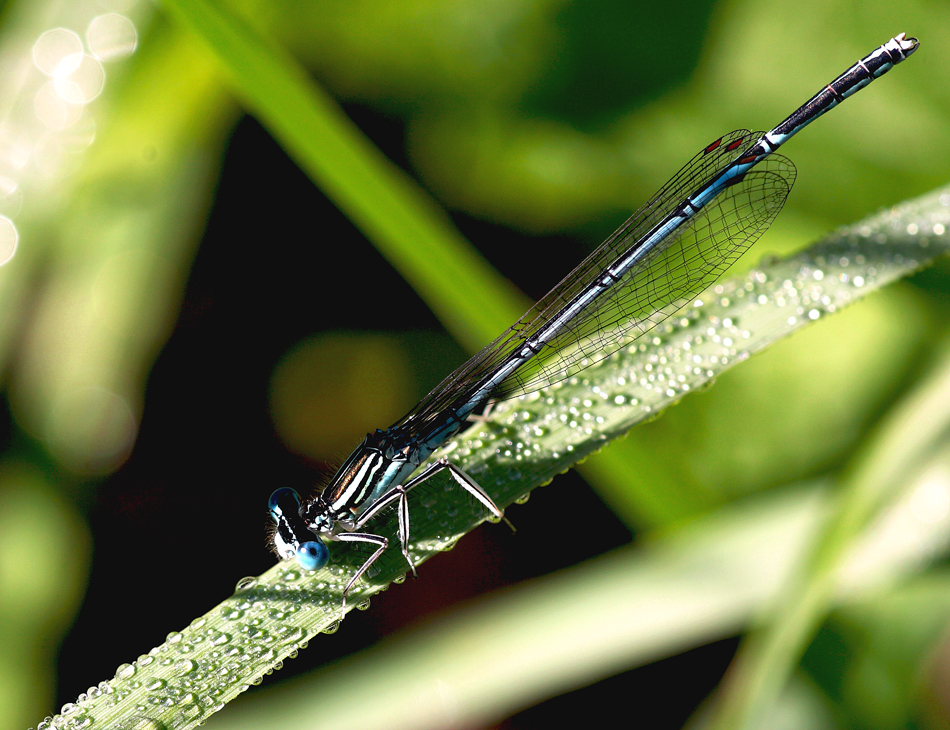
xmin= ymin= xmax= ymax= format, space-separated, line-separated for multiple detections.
xmin=397 ymin=135 xmax=795 ymax=429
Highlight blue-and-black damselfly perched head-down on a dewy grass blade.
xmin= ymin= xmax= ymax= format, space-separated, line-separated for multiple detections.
xmin=269 ymin=33 xmax=918 ymax=610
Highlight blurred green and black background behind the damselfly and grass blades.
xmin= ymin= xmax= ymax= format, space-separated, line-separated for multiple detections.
xmin=0 ymin=0 xmax=950 ymax=728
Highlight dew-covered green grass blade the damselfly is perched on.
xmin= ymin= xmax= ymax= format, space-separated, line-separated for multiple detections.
xmin=37 ymin=181 xmax=950 ymax=730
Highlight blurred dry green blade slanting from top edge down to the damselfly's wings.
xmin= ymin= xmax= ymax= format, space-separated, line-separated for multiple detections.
xmin=158 ymin=0 xmax=527 ymax=350
